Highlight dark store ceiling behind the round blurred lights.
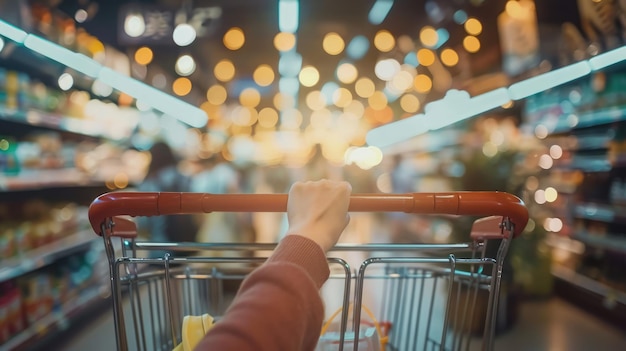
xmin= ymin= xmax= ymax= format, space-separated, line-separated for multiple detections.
xmin=44 ymin=0 xmax=577 ymax=108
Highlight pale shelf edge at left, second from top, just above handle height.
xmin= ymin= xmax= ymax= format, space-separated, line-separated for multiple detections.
xmin=0 ymin=168 xmax=104 ymax=192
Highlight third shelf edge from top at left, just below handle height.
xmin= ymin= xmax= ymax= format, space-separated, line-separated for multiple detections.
xmin=0 ymin=229 xmax=99 ymax=282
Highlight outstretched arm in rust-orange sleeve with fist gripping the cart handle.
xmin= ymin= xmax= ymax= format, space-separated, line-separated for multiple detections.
xmin=195 ymin=180 xmax=351 ymax=351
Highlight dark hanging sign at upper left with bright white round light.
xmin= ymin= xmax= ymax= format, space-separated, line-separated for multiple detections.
xmin=117 ymin=4 xmax=222 ymax=45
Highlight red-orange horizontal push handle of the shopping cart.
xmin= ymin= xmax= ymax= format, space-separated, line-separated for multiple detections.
xmin=89 ymin=191 xmax=528 ymax=236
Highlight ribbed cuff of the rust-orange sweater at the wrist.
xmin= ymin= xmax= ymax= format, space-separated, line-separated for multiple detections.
xmin=268 ymin=235 xmax=330 ymax=289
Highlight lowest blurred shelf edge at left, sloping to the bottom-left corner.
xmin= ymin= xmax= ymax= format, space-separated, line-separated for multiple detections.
xmin=0 ymin=285 xmax=108 ymax=351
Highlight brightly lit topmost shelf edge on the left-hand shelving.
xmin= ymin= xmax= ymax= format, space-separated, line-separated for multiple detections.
xmin=0 ymin=105 xmax=120 ymax=140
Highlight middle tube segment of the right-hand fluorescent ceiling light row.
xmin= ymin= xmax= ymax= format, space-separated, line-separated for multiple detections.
xmin=509 ymin=61 xmax=591 ymax=100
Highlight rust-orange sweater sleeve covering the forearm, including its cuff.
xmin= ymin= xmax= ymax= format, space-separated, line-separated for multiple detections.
xmin=195 ymin=235 xmax=330 ymax=351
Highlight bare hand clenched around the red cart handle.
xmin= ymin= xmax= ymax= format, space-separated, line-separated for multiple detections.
xmin=287 ymin=180 xmax=352 ymax=252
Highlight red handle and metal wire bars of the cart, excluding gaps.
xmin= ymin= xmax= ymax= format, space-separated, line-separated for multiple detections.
xmin=89 ymin=192 xmax=528 ymax=350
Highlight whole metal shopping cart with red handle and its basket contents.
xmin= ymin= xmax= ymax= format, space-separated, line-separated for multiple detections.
xmin=89 ymin=192 xmax=528 ymax=350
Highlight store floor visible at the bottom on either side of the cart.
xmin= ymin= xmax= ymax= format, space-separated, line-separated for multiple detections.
xmin=55 ymin=298 xmax=626 ymax=351
